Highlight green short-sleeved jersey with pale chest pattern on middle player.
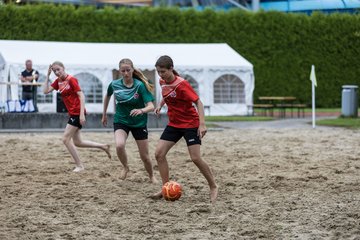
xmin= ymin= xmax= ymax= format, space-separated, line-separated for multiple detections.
xmin=107 ymin=78 xmax=154 ymax=128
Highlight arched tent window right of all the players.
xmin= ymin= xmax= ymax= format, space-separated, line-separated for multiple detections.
xmin=214 ymin=74 xmax=245 ymax=103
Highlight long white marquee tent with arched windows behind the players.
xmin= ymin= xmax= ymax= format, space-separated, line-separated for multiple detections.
xmin=0 ymin=40 xmax=254 ymax=115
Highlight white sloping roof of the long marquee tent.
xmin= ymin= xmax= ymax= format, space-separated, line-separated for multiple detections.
xmin=0 ymin=40 xmax=253 ymax=69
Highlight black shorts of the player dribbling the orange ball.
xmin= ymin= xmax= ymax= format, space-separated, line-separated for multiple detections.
xmin=160 ymin=126 xmax=201 ymax=146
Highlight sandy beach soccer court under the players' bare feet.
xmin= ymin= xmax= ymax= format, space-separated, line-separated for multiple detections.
xmin=0 ymin=128 xmax=360 ymax=240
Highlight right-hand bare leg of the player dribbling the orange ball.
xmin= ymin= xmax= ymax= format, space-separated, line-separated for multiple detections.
xmin=188 ymin=144 xmax=218 ymax=202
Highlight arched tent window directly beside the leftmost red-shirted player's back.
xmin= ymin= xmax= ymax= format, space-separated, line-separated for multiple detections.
xmin=74 ymin=73 xmax=102 ymax=103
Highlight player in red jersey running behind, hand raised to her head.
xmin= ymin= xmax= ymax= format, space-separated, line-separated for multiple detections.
xmin=44 ymin=61 xmax=111 ymax=172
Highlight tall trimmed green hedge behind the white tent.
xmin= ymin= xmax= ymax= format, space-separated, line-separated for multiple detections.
xmin=0 ymin=5 xmax=360 ymax=107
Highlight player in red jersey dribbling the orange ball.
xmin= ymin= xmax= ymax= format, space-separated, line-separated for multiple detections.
xmin=152 ymin=56 xmax=218 ymax=203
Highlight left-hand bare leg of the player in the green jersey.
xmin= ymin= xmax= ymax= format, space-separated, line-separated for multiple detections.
xmin=114 ymin=129 xmax=130 ymax=180
